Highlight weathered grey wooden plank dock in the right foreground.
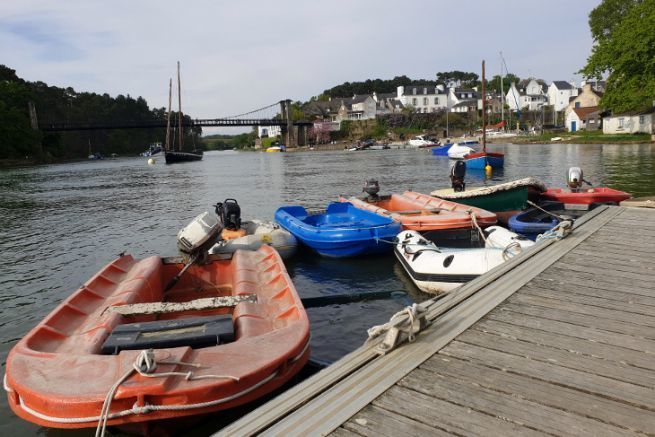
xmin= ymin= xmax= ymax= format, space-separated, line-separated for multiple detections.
xmin=218 ymin=207 xmax=655 ymax=436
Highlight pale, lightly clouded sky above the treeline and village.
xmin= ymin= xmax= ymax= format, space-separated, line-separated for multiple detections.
xmin=0 ymin=0 xmax=601 ymax=133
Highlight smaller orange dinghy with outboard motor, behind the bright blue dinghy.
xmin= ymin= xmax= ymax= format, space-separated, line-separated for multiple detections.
xmin=339 ymin=180 xmax=496 ymax=246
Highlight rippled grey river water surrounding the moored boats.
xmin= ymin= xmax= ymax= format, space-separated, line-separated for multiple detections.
xmin=0 ymin=144 xmax=655 ymax=435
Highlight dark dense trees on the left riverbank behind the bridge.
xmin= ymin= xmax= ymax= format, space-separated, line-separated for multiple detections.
xmin=0 ymin=65 xmax=201 ymax=163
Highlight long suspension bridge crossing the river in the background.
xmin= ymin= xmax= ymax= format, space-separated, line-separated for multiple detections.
xmin=36 ymin=99 xmax=312 ymax=147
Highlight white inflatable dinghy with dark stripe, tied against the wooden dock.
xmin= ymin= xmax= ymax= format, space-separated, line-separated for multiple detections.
xmin=394 ymin=226 xmax=535 ymax=294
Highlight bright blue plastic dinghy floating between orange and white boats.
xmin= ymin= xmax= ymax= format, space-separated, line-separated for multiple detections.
xmin=275 ymin=202 xmax=401 ymax=258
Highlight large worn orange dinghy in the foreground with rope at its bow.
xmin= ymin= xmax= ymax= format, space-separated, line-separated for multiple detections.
xmin=4 ymin=246 xmax=309 ymax=428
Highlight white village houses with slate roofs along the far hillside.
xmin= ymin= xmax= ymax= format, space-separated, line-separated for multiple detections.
xmin=282 ymin=78 xmax=654 ymax=140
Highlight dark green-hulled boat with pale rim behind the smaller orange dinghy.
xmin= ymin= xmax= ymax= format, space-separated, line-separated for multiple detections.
xmin=430 ymin=177 xmax=546 ymax=223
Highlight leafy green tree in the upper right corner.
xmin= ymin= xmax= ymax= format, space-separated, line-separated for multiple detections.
xmin=580 ymin=0 xmax=655 ymax=113
